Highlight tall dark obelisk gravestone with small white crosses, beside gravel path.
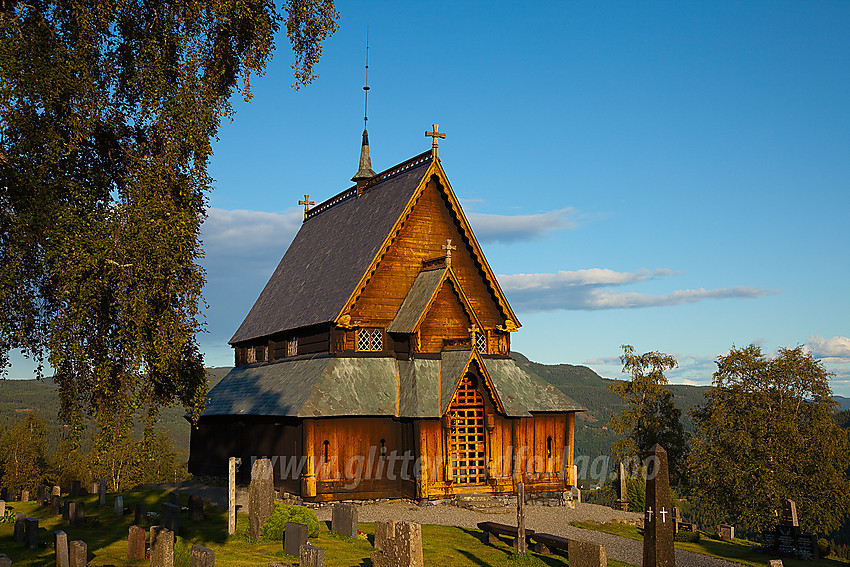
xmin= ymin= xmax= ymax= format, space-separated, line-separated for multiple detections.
xmin=643 ymin=443 xmax=676 ymax=567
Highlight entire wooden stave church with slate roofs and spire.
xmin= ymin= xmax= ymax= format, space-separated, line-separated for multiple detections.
xmin=189 ymin=125 xmax=582 ymax=501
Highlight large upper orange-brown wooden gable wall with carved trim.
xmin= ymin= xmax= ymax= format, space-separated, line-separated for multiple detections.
xmin=337 ymin=162 xmax=519 ymax=342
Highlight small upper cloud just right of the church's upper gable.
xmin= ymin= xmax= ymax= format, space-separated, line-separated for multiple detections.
xmin=466 ymin=207 xmax=577 ymax=243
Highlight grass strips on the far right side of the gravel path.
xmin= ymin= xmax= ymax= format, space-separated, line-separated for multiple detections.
xmin=570 ymin=522 xmax=850 ymax=567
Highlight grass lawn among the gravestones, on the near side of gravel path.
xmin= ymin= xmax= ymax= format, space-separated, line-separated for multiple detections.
xmin=0 ymin=491 xmax=628 ymax=567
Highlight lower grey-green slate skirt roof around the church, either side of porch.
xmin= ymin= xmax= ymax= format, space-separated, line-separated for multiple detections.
xmin=204 ymin=350 xmax=584 ymax=418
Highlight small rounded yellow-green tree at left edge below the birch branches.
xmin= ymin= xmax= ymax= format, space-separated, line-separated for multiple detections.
xmin=0 ymin=411 xmax=47 ymax=493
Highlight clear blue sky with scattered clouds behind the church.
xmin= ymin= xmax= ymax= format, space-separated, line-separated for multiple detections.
xmin=6 ymin=1 xmax=850 ymax=396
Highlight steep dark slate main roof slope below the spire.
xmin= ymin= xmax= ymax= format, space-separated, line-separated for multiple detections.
xmin=230 ymin=158 xmax=431 ymax=344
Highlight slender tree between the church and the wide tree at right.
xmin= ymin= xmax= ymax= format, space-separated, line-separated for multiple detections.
xmin=609 ymin=345 xmax=687 ymax=484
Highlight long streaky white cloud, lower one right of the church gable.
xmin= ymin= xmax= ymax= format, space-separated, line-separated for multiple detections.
xmin=499 ymin=268 xmax=774 ymax=312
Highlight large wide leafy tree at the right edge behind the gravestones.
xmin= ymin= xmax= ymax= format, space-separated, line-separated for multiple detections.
xmin=690 ymin=345 xmax=850 ymax=533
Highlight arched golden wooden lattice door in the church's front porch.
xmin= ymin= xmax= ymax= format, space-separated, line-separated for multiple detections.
xmin=449 ymin=376 xmax=487 ymax=484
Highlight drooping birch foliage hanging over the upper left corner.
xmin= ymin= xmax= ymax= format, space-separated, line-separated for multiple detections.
xmin=0 ymin=0 xmax=338 ymax=427
